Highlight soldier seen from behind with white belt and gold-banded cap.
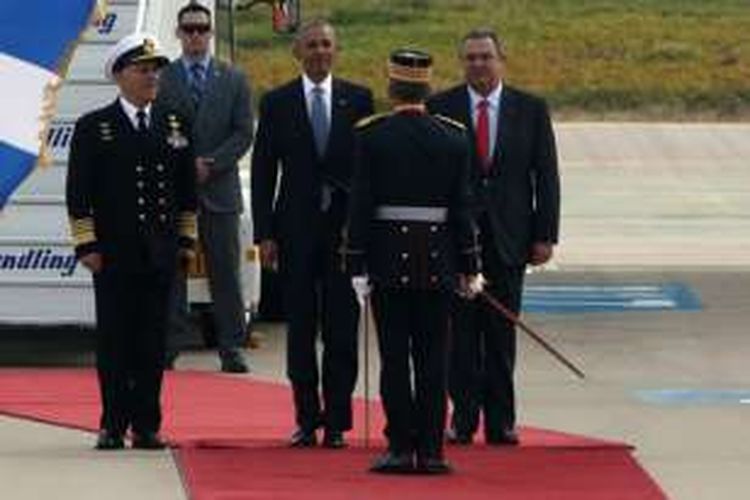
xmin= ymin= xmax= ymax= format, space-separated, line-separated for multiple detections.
xmin=346 ymin=50 xmax=479 ymax=473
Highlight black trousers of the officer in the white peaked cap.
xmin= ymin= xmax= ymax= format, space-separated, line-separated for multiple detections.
xmin=94 ymin=266 xmax=174 ymax=434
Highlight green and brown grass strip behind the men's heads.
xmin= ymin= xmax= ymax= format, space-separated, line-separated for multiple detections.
xmin=232 ymin=0 xmax=750 ymax=119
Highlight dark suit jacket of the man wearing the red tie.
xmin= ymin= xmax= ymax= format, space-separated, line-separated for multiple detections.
xmin=428 ymin=85 xmax=560 ymax=266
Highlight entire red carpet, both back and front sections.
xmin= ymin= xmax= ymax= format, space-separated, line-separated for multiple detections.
xmin=0 ymin=369 xmax=665 ymax=500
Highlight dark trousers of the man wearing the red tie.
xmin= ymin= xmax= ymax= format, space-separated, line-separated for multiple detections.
xmin=449 ymin=217 xmax=525 ymax=438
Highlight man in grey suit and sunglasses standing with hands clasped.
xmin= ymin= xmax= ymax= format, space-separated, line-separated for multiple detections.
xmin=159 ymin=2 xmax=253 ymax=373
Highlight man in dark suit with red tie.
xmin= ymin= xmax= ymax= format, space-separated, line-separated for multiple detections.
xmin=428 ymin=29 xmax=560 ymax=445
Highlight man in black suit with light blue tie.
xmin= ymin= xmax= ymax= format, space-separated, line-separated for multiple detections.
xmin=252 ymin=20 xmax=372 ymax=448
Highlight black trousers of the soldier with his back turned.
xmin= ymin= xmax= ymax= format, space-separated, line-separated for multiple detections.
xmin=372 ymin=289 xmax=450 ymax=457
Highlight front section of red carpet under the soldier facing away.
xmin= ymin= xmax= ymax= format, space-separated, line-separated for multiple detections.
xmin=177 ymin=446 xmax=666 ymax=500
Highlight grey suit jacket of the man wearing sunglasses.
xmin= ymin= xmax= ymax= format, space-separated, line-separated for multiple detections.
xmin=158 ymin=58 xmax=253 ymax=213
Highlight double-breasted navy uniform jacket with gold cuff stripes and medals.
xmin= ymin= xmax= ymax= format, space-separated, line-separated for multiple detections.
xmin=66 ymin=101 xmax=196 ymax=272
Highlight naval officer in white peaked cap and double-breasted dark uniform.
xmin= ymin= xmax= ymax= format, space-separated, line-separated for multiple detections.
xmin=66 ymin=33 xmax=196 ymax=450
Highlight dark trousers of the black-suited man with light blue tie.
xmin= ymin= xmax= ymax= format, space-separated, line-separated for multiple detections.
xmin=280 ymin=216 xmax=359 ymax=431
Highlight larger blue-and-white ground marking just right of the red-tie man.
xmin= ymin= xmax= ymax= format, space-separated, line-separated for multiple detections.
xmin=523 ymin=283 xmax=702 ymax=313
